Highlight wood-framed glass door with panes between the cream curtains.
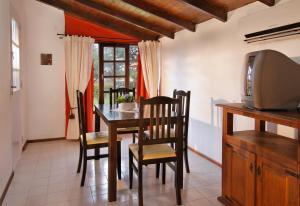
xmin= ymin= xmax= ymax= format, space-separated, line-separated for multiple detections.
xmin=93 ymin=43 xmax=138 ymax=104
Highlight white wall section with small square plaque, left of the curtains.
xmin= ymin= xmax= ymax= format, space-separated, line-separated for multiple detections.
xmin=24 ymin=0 xmax=65 ymax=139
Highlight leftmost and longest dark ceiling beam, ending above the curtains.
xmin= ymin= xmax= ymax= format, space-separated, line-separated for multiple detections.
xmin=37 ymin=0 xmax=159 ymax=40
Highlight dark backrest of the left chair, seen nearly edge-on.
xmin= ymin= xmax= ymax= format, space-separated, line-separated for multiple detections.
xmin=76 ymin=90 xmax=86 ymax=144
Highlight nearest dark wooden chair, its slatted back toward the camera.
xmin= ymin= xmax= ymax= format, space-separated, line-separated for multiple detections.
xmin=129 ymin=96 xmax=183 ymax=206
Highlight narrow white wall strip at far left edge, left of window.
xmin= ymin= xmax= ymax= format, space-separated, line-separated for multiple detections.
xmin=0 ymin=0 xmax=12 ymax=194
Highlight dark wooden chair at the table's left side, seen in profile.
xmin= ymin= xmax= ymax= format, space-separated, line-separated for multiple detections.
xmin=77 ymin=90 xmax=121 ymax=186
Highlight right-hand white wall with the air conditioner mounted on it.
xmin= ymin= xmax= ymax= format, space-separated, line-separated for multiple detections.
xmin=162 ymin=0 xmax=300 ymax=162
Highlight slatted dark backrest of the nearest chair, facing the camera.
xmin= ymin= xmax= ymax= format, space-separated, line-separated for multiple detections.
xmin=138 ymin=96 xmax=183 ymax=157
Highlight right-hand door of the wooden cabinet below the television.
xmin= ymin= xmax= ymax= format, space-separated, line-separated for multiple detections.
xmin=256 ymin=158 xmax=299 ymax=206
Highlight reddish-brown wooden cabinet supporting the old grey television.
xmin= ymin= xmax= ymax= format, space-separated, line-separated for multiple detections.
xmin=218 ymin=104 xmax=300 ymax=206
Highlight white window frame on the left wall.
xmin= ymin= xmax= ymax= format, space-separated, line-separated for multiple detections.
xmin=10 ymin=15 xmax=22 ymax=95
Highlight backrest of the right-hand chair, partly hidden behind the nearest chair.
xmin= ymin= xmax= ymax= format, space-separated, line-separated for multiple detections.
xmin=173 ymin=89 xmax=191 ymax=138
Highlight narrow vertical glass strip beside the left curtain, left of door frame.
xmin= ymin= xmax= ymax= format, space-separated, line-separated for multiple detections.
xmin=93 ymin=44 xmax=99 ymax=104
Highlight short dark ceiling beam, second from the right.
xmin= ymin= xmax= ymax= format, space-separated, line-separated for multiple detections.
xmin=181 ymin=0 xmax=227 ymax=22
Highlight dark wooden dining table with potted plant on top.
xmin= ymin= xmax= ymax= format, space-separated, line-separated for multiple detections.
xmin=94 ymin=104 xmax=183 ymax=202
